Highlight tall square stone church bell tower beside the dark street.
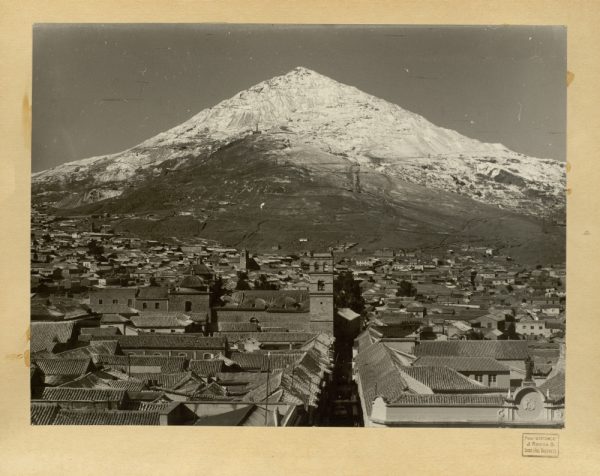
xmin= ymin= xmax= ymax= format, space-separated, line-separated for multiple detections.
xmin=309 ymin=253 xmax=333 ymax=335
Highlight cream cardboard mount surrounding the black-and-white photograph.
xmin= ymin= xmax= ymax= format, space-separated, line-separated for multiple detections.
xmin=0 ymin=0 xmax=600 ymax=475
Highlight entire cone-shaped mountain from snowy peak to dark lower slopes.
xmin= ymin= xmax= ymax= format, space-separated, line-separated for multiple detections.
xmin=32 ymin=68 xmax=565 ymax=260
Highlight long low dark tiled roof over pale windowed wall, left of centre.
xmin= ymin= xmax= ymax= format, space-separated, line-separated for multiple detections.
xmin=92 ymin=334 xmax=227 ymax=350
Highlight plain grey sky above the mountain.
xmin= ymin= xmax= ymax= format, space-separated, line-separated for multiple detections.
xmin=32 ymin=24 xmax=566 ymax=172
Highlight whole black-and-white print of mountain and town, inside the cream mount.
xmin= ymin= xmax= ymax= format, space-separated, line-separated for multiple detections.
xmin=30 ymin=23 xmax=567 ymax=428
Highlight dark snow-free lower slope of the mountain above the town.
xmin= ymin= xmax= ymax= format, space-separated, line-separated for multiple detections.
xmin=56 ymin=135 xmax=564 ymax=263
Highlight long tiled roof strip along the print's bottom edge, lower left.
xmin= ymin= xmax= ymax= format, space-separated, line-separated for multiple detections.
xmin=54 ymin=410 xmax=160 ymax=425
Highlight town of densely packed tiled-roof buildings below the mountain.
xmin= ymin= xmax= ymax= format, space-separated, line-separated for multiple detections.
xmin=30 ymin=205 xmax=566 ymax=427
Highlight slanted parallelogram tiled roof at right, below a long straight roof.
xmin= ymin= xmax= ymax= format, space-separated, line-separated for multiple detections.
xmin=399 ymin=367 xmax=492 ymax=393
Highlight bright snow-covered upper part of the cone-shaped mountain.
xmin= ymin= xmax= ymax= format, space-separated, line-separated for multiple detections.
xmin=32 ymin=67 xmax=565 ymax=214
